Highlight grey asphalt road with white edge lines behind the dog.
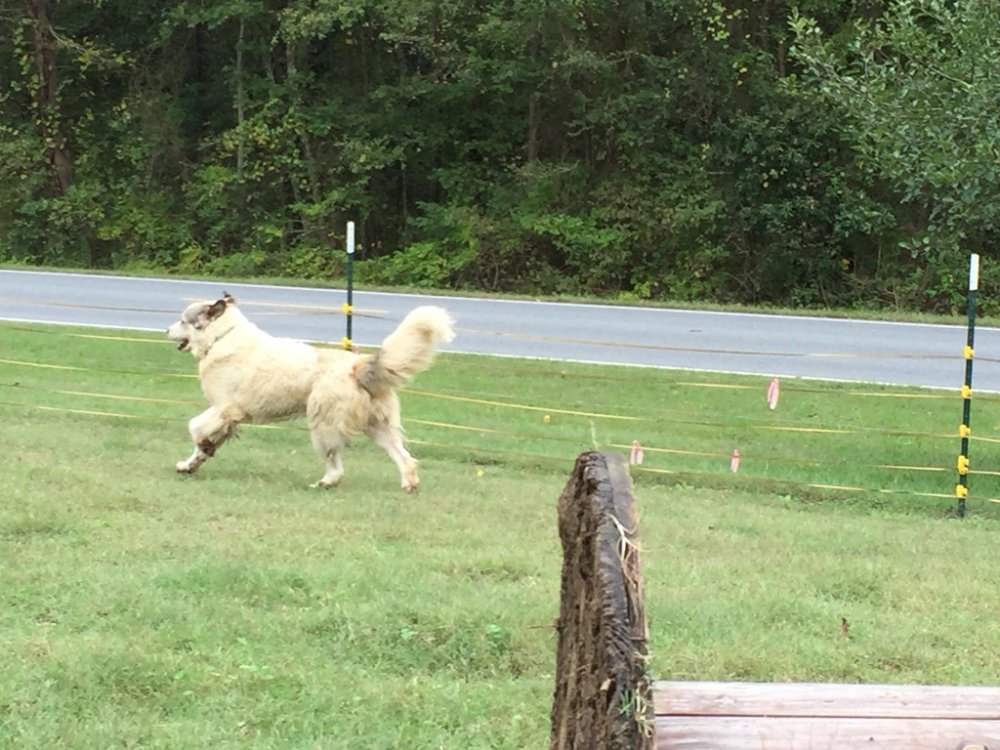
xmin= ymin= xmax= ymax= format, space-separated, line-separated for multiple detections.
xmin=0 ymin=270 xmax=1000 ymax=391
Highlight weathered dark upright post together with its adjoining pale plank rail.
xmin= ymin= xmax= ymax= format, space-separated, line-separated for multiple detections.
xmin=549 ymin=452 xmax=1000 ymax=750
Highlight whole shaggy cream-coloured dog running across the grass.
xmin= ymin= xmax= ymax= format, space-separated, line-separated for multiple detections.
xmin=167 ymin=294 xmax=454 ymax=492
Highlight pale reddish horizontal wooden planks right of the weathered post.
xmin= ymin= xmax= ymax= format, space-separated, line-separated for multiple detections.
xmin=653 ymin=682 xmax=1000 ymax=750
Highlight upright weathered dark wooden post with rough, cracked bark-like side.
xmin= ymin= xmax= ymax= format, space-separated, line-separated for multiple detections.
xmin=550 ymin=452 xmax=655 ymax=750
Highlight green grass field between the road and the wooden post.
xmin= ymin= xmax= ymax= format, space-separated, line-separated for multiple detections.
xmin=0 ymin=325 xmax=1000 ymax=750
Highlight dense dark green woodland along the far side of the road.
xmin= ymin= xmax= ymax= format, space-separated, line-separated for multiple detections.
xmin=0 ymin=0 xmax=1000 ymax=312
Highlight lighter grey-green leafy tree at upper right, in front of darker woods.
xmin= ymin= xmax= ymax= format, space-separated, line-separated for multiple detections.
xmin=792 ymin=0 xmax=1000 ymax=310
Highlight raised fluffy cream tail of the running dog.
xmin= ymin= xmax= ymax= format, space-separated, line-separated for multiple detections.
xmin=355 ymin=305 xmax=455 ymax=394
